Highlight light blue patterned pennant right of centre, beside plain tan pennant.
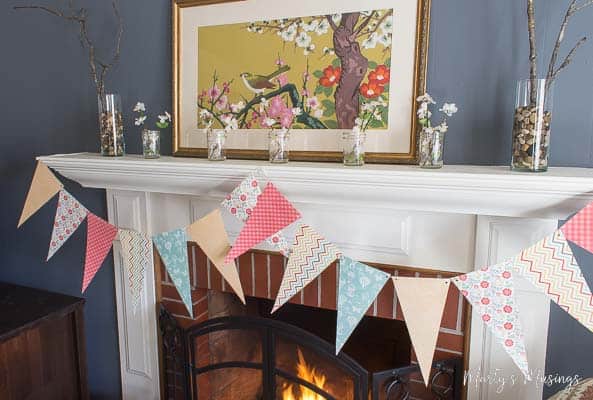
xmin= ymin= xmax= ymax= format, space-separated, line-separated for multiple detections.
xmin=336 ymin=256 xmax=389 ymax=354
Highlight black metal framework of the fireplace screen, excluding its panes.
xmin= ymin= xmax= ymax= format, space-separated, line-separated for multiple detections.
xmin=159 ymin=306 xmax=463 ymax=400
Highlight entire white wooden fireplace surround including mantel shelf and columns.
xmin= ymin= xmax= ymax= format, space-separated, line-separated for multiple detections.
xmin=39 ymin=153 xmax=593 ymax=400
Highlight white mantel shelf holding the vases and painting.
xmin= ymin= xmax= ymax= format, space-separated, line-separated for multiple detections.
xmin=38 ymin=153 xmax=593 ymax=219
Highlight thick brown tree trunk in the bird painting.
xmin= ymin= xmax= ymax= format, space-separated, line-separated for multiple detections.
xmin=334 ymin=13 xmax=369 ymax=129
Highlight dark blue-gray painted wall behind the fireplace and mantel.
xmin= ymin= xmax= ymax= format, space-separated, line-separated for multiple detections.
xmin=0 ymin=0 xmax=593 ymax=399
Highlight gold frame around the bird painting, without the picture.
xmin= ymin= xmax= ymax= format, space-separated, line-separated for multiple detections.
xmin=172 ymin=0 xmax=431 ymax=164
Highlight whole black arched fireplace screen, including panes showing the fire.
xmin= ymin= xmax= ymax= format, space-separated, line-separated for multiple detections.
xmin=160 ymin=308 xmax=462 ymax=400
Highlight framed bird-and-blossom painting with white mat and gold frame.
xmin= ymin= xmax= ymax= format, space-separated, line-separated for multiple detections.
xmin=173 ymin=0 xmax=430 ymax=163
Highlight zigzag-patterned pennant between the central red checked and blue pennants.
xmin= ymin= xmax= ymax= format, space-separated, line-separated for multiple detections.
xmin=272 ymin=225 xmax=340 ymax=312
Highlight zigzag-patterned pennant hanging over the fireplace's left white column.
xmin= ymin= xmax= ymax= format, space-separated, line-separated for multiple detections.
xmin=119 ymin=229 xmax=152 ymax=314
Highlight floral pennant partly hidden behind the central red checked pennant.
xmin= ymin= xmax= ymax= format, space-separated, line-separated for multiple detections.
xmin=221 ymin=170 xmax=290 ymax=257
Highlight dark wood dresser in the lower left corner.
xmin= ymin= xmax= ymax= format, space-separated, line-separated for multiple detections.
xmin=0 ymin=282 xmax=88 ymax=400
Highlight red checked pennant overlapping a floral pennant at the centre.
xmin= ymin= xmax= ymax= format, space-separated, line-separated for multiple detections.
xmin=224 ymin=183 xmax=301 ymax=263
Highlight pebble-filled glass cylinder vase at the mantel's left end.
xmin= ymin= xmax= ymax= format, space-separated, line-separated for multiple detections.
xmin=99 ymin=94 xmax=126 ymax=157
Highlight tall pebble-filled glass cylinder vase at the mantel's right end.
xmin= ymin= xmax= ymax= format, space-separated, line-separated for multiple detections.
xmin=511 ymin=79 xmax=554 ymax=172
